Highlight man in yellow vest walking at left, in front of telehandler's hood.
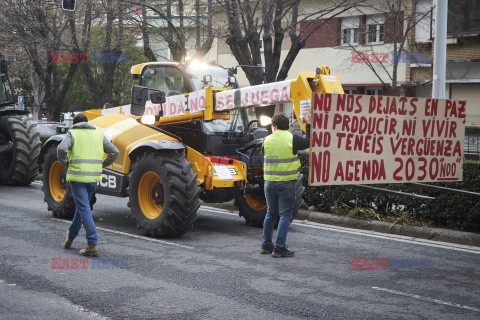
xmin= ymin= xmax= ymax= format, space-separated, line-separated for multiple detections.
xmin=57 ymin=113 xmax=118 ymax=257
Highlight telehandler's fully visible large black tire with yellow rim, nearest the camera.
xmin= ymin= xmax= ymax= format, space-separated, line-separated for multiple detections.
xmin=128 ymin=151 xmax=200 ymax=237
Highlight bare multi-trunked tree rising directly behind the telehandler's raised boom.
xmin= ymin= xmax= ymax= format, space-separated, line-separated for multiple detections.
xmin=219 ymin=0 xmax=362 ymax=84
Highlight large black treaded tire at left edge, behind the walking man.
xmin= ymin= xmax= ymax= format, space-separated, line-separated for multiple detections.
xmin=0 ymin=115 xmax=42 ymax=186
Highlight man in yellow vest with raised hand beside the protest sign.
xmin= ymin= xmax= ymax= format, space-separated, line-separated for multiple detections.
xmin=260 ymin=114 xmax=310 ymax=258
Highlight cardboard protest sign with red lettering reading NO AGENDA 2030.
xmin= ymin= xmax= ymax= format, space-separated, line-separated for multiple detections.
xmin=308 ymin=93 xmax=466 ymax=186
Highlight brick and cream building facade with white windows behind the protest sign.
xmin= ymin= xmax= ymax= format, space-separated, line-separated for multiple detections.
xmin=217 ymin=0 xmax=480 ymax=154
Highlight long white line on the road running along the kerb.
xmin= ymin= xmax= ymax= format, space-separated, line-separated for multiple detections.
xmin=201 ymin=206 xmax=480 ymax=254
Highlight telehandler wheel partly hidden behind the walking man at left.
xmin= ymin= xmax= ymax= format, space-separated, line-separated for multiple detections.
xmin=42 ymin=145 xmax=75 ymax=220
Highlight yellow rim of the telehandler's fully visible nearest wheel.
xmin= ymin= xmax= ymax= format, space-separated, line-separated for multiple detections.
xmin=138 ymin=171 xmax=165 ymax=220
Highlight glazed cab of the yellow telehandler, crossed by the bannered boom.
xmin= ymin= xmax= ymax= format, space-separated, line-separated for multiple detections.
xmin=132 ymin=61 xmax=268 ymax=158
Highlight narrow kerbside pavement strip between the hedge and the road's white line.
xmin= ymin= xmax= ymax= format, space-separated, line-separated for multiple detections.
xmin=206 ymin=201 xmax=480 ymax=247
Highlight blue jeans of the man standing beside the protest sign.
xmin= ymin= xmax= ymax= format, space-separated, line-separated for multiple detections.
xmin=263 ymin=181 xmax=295 ymax=248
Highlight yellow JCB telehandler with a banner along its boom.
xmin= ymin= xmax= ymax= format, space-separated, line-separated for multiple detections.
xmin=40 ymin=62 xmax=343 ymax=237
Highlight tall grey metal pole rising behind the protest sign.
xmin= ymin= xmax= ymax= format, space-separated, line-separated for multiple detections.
xmin=432 ymin=0 xmax=448 ymax=99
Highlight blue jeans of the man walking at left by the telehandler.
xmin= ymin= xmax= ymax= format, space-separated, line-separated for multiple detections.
xmin=68 ymin=181 xmax=98 ymax=246
